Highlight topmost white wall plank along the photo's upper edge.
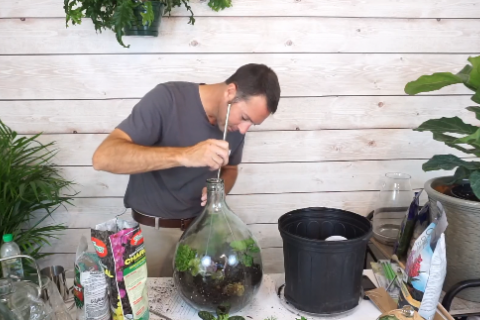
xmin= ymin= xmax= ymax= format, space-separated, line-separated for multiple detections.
xmin=0 ymin=0 xmax=478 ymax=18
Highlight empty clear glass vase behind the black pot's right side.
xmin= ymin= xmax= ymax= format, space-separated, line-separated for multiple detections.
xmin=373 ymin=172 xmax=413 ymax=245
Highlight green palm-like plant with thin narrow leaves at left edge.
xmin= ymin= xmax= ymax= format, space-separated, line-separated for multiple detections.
xmin=0 ymin=120 xmax=72 ymax=276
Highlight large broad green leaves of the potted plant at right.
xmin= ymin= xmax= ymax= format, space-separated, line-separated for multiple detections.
xmin=405 ymin=56 xmax=480 ymax=199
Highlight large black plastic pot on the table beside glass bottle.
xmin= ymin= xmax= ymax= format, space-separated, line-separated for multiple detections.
xmin=278 ymin=207 xmax=372 ymax=314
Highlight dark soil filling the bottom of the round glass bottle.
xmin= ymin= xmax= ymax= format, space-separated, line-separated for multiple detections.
xmin=178 ymin=263 xmax=262 ymax=313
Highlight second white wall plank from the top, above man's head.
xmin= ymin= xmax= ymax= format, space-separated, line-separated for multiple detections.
xmin=0 ymin=17 xmax=480 ymax=54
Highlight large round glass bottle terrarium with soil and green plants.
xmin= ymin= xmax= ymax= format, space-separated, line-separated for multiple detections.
xmin=173 ymin=179 xmax=263 ymax=314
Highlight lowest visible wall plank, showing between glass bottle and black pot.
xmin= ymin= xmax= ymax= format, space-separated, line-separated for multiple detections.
xmin=39 ymin=247 xmax=283 ymax=273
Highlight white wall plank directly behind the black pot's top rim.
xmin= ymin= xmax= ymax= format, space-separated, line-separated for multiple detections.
xmin=31 ymin=191 xmax=384 ymax=229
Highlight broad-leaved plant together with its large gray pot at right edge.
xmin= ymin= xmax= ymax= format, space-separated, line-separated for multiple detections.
xmin=405 ymin=56 xmax=480 ymax=302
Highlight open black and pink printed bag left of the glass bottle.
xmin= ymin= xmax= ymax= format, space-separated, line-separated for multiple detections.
xmin=91 ymin=219 xmax=149 ymax=320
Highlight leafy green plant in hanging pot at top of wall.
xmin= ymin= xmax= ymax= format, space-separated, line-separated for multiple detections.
xmin=63 ymin=0 xmax=232 ymax=48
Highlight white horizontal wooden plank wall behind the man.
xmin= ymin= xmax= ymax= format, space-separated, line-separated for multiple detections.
xmin=0 ymin=0 xmax=480 ymax=271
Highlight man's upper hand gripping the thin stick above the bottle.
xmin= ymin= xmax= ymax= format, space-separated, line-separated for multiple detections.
xmin=181 ymin=139 xmax=229 ymax=171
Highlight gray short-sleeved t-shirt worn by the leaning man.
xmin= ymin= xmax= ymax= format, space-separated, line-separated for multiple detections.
xmin=117 ymin=82 xmax=245 ymax=219
